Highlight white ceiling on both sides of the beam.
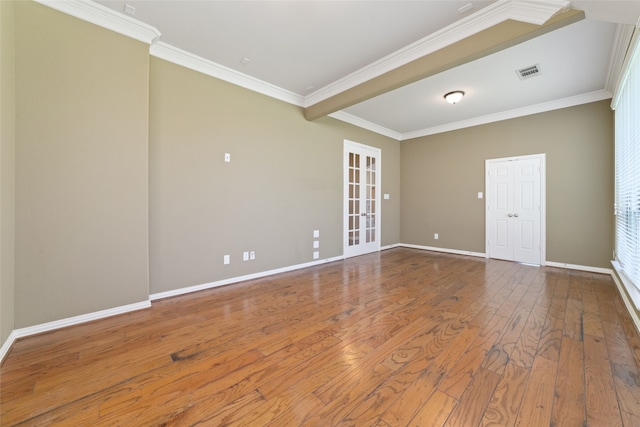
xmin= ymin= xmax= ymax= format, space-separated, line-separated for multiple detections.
xmin=97 ymin=0 xmax=640 ymax=139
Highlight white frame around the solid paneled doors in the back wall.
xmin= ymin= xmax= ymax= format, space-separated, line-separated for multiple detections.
xmin=484 ymin=153 xmax=547 ymax=266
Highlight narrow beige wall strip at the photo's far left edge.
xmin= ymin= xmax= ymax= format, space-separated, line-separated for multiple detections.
xmin=0 ymin=1 xmax=15 ymax=345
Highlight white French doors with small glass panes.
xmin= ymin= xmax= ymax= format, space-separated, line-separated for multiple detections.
xmin=344 ymin=140 xmax=381 ymax=257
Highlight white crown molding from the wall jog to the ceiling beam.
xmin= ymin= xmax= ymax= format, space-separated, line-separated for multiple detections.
xmin=149 ymin=42 xmax=303 ymax=107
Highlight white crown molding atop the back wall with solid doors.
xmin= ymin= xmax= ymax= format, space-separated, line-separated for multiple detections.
xmin=401 ymin=90 xmax=612 ymax=141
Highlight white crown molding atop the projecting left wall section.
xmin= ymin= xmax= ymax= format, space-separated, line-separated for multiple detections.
xmin=33 ymin=0 xmax=160 ymax=44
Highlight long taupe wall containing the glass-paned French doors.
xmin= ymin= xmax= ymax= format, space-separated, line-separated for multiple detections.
xmin=150 ymin=58 xmax=400 ymax=293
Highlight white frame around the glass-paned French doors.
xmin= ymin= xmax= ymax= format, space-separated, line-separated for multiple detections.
xmin=342 ymin=139 xmax=382 ymax=258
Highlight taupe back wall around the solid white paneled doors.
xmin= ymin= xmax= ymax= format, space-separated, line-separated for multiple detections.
xmin=400 ymin=101 xmax=614 ymax=268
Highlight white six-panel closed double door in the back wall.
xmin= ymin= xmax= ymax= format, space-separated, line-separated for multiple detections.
xmin=486 ymin=154 xmax=545 ymax=265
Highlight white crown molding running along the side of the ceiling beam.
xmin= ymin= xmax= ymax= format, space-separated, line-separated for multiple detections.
xmin=304 ymin=0 xmax=570 ymax=108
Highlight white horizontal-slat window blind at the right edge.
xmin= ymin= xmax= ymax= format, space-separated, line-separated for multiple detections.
xmin=614 ymin=28 xmax=640 ymax=307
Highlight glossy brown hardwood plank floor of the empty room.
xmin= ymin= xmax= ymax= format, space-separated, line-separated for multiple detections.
xmin=0 ymin=248 xmax=640 ymax=427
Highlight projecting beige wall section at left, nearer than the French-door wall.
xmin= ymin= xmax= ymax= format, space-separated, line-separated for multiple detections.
xmin=15 ymin=2 xmax=149 ymax=328
